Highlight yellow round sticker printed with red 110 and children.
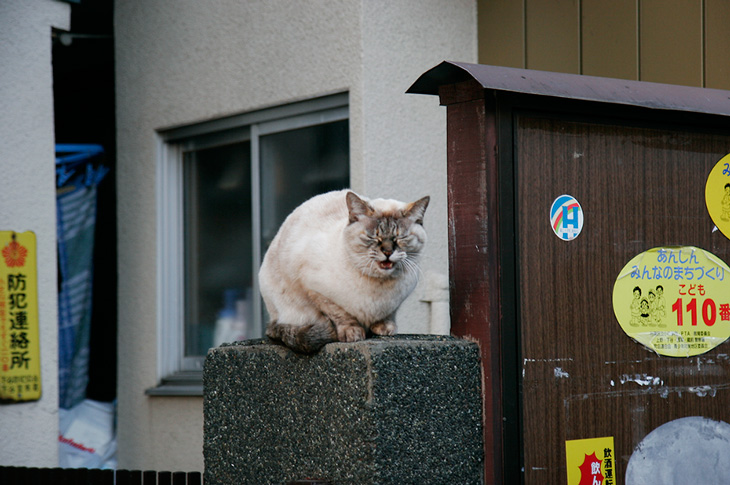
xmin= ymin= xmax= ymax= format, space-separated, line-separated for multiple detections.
xmin=613 ymin=246 xmax=730 ymax=357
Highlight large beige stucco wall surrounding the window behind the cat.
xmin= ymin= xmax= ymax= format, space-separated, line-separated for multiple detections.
xmin=115 ymin=0 xmax=476 ymax=470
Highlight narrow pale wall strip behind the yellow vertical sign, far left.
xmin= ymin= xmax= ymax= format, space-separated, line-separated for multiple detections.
xmin=0 ymin=0 xmax=70 ymax=467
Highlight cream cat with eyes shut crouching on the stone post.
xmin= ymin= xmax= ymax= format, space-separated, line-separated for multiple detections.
xmin=259 ymin=190 xmax=430 ymax=353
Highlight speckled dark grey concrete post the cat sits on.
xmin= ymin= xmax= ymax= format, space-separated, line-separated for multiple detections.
xmin=203 ymin=335 xmax=483 ymax=485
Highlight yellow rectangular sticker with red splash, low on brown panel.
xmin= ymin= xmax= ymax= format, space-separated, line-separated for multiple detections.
xmin=565 ymin=436 xmax=616 ymax=485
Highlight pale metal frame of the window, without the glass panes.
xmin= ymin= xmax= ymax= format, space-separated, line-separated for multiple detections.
xmin=147 ymin=93 xmax=349 ymax=395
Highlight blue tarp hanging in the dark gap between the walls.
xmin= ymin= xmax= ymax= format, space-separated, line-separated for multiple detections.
xmin=56 ymin=145 xmax=108 ymax=409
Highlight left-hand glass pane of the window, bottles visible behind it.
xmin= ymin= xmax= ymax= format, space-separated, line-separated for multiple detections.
xmin=183 ymin=142 xmax=261 ymax=356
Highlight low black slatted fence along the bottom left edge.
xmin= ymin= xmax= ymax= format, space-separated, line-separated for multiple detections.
xmin=0 ymin=466 xmax=203 ymax=485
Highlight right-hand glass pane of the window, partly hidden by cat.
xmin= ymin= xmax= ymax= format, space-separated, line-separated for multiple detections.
xmin=259 ymin=120 xmax=350 ymax=250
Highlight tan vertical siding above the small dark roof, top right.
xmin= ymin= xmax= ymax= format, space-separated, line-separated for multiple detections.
xmin=477 ymin=0 xmax=730 ymax=89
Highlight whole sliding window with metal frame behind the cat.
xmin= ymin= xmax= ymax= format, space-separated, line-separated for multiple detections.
xmin=148 ymin=94 xmax=349 ymax=394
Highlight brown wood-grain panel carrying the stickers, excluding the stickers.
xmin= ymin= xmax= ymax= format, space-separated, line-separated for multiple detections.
xmin=514 ymin=113 xmax=730 ymax=484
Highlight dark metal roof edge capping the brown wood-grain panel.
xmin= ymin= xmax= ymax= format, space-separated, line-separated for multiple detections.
xmin=406 ymin=61 xmax=730 ymax=116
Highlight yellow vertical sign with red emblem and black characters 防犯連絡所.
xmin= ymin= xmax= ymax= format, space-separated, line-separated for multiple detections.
xmin=0 ymin=231 xmax=41 ymax=402
